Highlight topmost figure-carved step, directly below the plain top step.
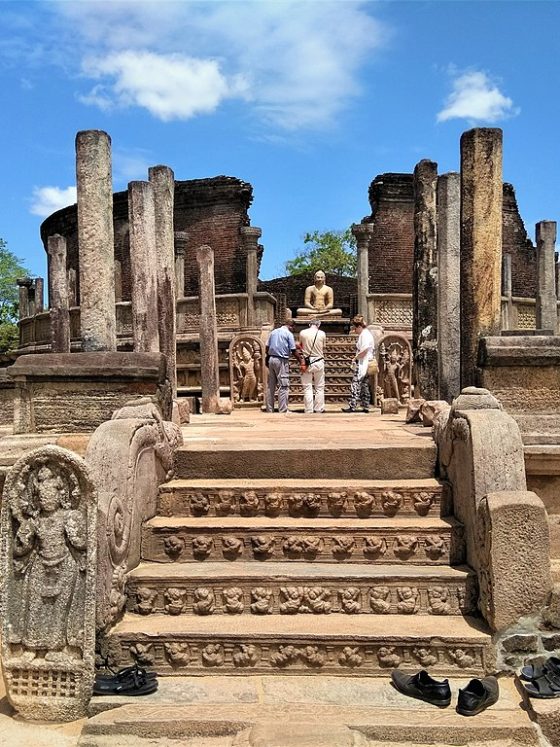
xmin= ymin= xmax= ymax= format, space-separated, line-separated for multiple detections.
xmin=157 ymin=479 xmax=448 ymax=518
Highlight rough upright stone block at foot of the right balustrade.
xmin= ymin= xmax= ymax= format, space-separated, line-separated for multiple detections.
xmin=477 ymin=491 xmax=552 ymax=630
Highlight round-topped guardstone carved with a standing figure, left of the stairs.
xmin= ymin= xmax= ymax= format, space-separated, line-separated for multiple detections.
xmin=1 ymin=446 xmax=97 ymax=721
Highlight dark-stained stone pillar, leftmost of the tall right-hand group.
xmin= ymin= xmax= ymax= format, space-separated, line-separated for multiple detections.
xmin=412 ymin=160 xmax=438 ymax=399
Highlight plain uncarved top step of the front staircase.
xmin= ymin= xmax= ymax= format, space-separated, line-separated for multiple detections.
xmin=175 ymin=442 xmax=437 ymax=482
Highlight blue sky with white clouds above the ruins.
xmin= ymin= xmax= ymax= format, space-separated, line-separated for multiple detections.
xmin=0 ymin=0 xmax=560 ymax=279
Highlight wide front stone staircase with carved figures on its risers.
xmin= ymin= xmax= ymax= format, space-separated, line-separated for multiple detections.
xmin=103 ymin=436 xmax=490 ymax=677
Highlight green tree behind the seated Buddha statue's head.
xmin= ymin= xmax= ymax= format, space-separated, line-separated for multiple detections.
xmin=285 ymin=228 xmax=356 ymax=277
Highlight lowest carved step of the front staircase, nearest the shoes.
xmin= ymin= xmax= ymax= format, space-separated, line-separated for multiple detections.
xmin=104 ymin=614 xmax=492 ymax=676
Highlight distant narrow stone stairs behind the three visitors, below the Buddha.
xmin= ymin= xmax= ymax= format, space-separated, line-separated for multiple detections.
xmin=290 ymin=335 xmax=356 ymax=405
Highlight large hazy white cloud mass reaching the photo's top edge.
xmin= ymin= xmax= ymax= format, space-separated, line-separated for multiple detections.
xmin=52 ymin=0 xmax=389 ymax=130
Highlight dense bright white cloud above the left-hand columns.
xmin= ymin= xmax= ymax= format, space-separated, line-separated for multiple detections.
xmin=84 ymin=50 xmax=247 ymax=122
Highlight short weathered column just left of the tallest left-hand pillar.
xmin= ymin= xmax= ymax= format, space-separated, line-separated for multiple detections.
xmin=47 ymin=234 xmax=70 ymax=353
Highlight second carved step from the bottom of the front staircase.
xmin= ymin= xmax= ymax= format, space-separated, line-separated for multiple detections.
xmin=127 ymin=562 xmax=476 ymax=615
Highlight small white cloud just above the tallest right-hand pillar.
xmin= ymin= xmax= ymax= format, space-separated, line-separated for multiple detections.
xmin=437 ymin=71 xmax=519 ymax=124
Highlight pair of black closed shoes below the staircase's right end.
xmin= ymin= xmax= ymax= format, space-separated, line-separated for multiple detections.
xmin=391 ymin=669 xmax=500 ymax=716
